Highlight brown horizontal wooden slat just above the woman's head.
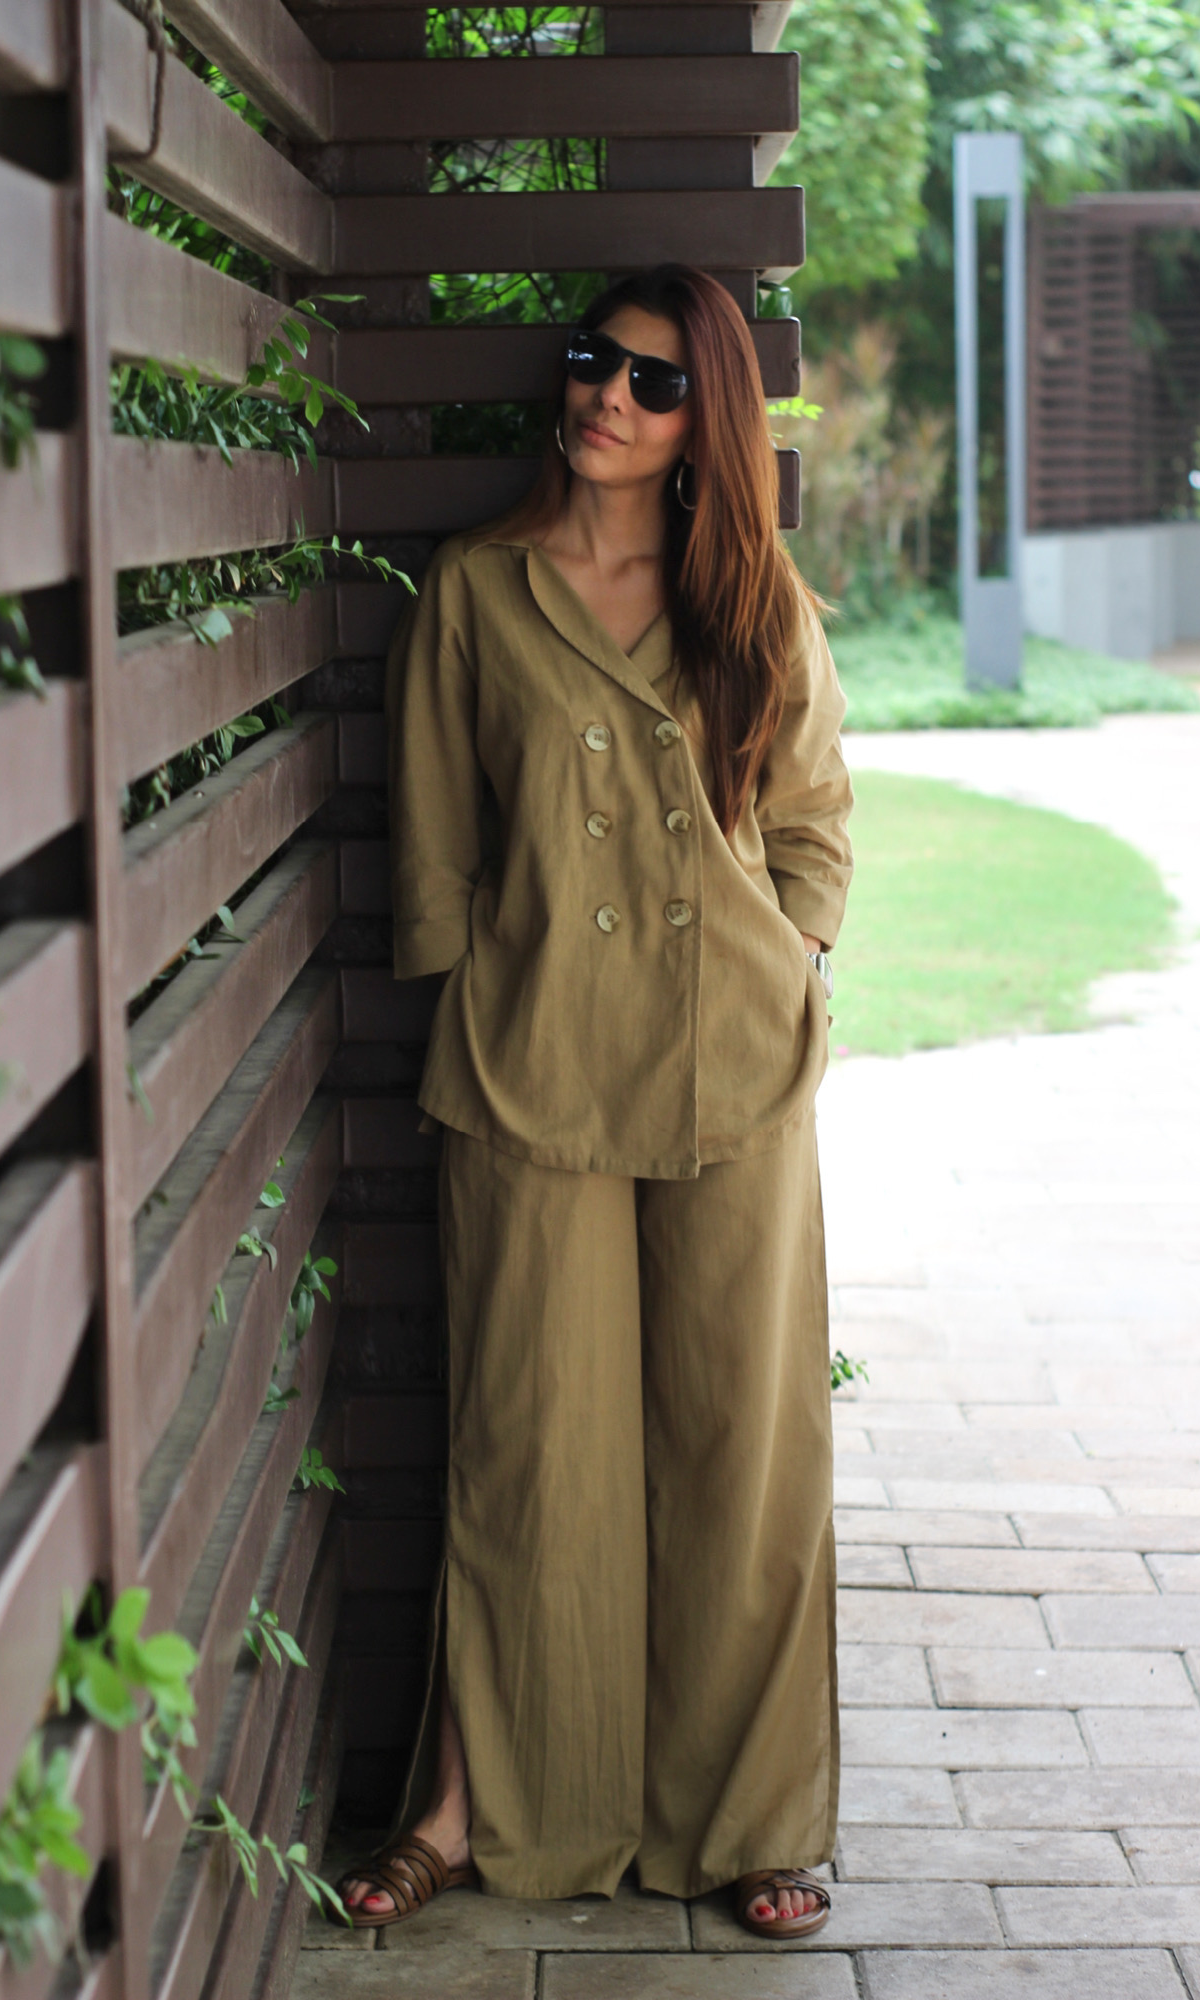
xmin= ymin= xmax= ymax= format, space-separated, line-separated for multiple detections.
xmin=332 ymin=183 xmax=804 ymax=276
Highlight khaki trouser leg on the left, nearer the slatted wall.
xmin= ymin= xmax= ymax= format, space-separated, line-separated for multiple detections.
xmin=442 ymin=1132 xmax=646 ymax=1896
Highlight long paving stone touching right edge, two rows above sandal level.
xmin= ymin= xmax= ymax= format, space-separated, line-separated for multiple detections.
xmin=954 ymin=1768 xmax=1200 ymax=1830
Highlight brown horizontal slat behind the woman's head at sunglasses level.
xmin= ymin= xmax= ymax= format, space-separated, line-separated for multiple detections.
xmin=336 ymin=312 xmax=800 ymax=408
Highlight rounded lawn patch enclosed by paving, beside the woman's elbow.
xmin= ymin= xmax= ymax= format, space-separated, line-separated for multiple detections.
xmin=830 ymin=772 xmax=1174 ymax=1056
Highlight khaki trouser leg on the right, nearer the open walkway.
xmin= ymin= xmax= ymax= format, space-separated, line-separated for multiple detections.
xmin=638 ymin=1118 xmax=838 ymax=1896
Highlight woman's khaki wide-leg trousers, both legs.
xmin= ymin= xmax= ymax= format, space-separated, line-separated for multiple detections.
xmin=402 ymin=1116 xmax=838 ymax=1896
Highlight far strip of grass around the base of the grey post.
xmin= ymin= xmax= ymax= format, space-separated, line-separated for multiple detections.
xmin=830 ymin=612 xmax=1200 ymax=730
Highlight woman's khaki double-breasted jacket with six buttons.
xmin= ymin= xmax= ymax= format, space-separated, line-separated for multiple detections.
xmin=388 ymin=530 xmax=852 ymax=1180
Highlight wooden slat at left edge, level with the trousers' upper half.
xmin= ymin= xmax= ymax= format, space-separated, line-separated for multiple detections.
xmin=0 ymin=1160 xmax=96 ymax=1484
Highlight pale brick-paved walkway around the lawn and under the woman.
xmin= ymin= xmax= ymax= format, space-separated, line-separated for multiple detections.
xmin=294 ymin=716 xmax=1200 ymax=2000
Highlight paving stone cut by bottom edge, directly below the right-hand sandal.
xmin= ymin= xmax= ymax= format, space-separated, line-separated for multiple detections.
xmin=542 ymin=1950 xmax=858 ymax=2000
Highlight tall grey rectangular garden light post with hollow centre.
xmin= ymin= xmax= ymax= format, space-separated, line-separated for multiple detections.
xmin=954 ymin=132 xmax=1026 ymax=688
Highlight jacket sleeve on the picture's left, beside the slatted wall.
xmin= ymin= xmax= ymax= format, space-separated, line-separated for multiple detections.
xmin=386 ymin=558 xmax=482 ymax=980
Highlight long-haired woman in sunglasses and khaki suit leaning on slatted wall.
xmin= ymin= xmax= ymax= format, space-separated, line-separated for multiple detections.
xmin=344 ymin=266 xmax=850 ymax=1938
